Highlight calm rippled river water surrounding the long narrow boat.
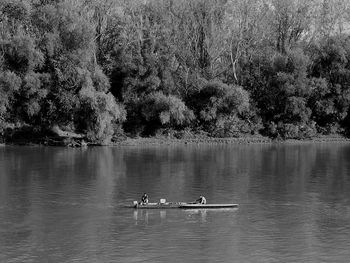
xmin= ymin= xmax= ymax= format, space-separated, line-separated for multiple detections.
xmin=0 ymin=143 xmax=350 ymax=263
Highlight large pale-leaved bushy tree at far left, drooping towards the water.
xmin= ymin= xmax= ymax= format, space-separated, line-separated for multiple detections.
xmin=0 ymin=1 xmax=125 ymax=141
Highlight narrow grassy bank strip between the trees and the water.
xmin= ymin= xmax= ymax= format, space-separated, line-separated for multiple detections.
xmin=0 ymin=128 xmax=350 ymax=147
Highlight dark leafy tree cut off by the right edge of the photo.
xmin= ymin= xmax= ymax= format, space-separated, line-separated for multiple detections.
xmin=310 ymin=36 xmax=350 ymax=133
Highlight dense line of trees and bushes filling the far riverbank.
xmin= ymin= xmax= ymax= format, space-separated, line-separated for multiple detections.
xmin=0 ymin=0 xmax=350 ymax=144
